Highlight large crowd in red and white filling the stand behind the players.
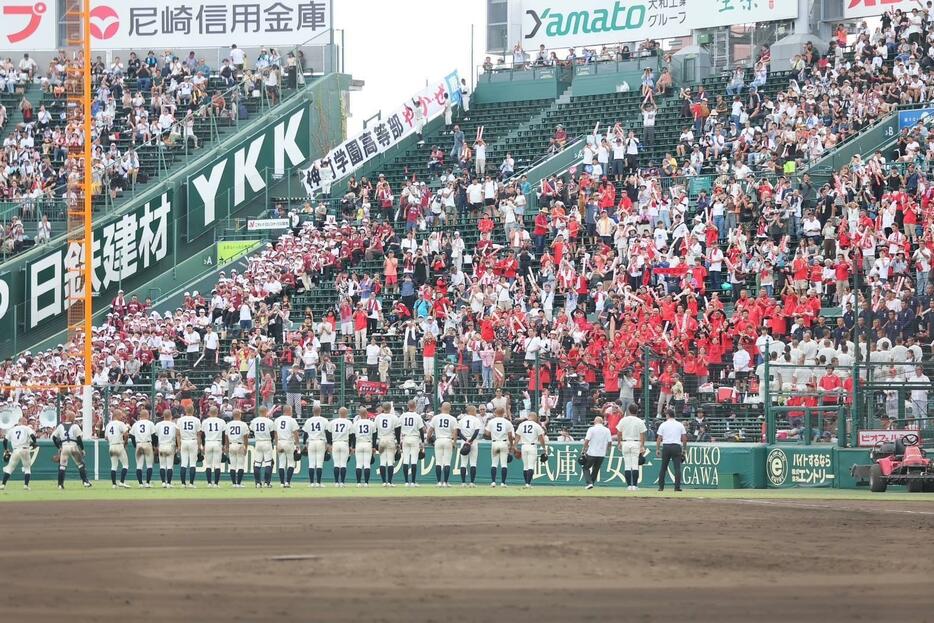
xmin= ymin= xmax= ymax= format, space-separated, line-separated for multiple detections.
xmin=0 ymin=11 xmax=934 ymax=439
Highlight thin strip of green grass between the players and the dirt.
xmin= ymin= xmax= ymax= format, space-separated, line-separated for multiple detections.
xmin=0 ymin=480 xmax=934 ymax=503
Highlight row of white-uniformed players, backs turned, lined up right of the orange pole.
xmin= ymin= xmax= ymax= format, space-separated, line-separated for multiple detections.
xmin=83 ymin=401 xmax=547 ymax=488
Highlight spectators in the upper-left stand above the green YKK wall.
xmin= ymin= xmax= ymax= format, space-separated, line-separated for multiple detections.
xmin=0 ymin=45 xmax=304 ymax=256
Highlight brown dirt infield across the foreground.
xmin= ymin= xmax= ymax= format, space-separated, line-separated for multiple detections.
xmin=0 ymin=498 xmax=934 ymax=623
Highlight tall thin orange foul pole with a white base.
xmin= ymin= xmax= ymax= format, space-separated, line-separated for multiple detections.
xmin=81 ymin=0 xmax=94 ymax=439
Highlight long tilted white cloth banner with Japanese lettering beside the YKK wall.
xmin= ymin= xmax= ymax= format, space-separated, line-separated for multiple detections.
xmin=302 ymin=71 xmax=460 ymax=195
